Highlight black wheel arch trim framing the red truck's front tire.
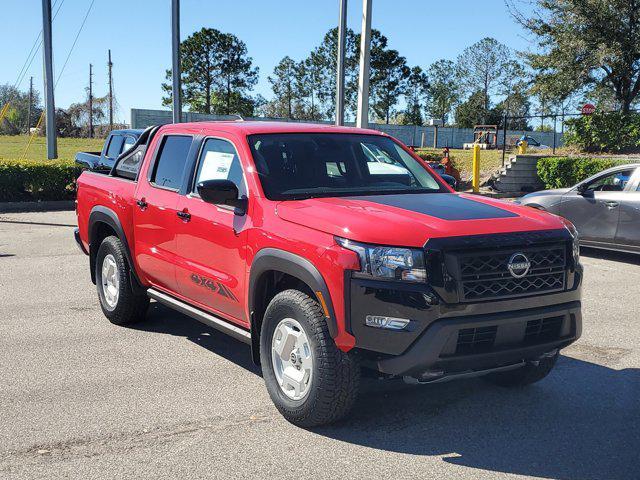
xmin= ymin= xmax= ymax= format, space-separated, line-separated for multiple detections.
xmin=248 ymin=248 xmax=338 ymax=364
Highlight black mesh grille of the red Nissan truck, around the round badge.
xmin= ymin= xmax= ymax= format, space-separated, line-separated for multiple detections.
xmin=457 ymin=244 xmax=566 ymax=301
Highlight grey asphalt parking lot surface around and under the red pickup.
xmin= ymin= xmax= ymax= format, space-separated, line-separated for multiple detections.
xmin=0 ymin=212 xmax=640 ymax=480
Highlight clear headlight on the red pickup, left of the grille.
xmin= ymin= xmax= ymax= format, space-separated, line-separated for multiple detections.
xmin=336 ymin=237 xmax=427 ymax=282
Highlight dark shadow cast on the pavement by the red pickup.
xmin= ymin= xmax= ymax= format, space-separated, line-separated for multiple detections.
xmin=138 ymin=303 xmax=640 ymax=480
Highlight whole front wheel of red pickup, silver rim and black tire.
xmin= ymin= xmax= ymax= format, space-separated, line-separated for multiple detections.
xmin=260 ymin=290 xmax=360 ymax=427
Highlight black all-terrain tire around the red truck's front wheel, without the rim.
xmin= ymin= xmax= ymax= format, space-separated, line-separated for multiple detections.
xmin=260 ymin=290 xmax=360 ymax=428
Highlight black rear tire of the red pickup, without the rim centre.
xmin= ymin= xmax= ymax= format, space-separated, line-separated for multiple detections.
xmin=95 ymin=236 xmax=149 ymax=325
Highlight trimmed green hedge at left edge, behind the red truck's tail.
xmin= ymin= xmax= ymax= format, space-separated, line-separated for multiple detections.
xmin=0 ymin=159 xmax=82 ymax=202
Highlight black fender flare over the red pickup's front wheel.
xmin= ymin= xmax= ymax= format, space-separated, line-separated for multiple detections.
xmin=248 ymin=248 xmax=338 ymax=339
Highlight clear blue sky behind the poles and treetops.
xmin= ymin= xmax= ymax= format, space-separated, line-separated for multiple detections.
xmin=0 ymin=0 xmax=530 ymax=121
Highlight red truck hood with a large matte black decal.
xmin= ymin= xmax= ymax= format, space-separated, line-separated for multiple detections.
xmin=276 ymin=193 xmax=564 ymax=247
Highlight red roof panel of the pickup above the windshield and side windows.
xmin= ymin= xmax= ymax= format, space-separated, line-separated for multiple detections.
xmin=155 ymin=120 xmax=384 ymax=135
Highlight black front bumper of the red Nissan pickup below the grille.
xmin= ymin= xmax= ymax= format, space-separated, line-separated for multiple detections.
xmin=347 ymin=267 xmax=582 ymax=379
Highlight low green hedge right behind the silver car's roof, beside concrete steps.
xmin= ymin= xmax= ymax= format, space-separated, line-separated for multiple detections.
xmin=538 ymin=157 xmax=625 ymax=188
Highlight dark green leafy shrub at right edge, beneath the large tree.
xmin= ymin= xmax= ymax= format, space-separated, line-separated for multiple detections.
xmin=564 ymin=113 xmax=640 ymax=152
